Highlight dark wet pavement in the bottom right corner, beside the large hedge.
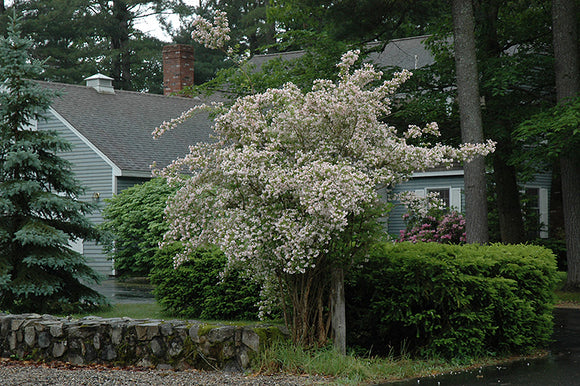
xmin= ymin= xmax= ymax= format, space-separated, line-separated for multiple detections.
xmin=385 ymin=308 xmax=580 ymax=386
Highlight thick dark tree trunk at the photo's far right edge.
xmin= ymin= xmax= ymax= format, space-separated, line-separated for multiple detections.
xmin=552 ymin=0 xmax=580 ymax=289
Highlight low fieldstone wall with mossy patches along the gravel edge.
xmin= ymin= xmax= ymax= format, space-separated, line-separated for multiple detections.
xmin=0 ymin=313 xmax=287 ymax=371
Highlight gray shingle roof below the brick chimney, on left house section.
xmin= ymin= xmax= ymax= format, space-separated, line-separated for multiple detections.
xmin=38 ymin=81 xmax=218 ymax=172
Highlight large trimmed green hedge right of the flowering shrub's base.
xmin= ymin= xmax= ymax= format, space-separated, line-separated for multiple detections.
xmin=346 ymin=243 xmax=557 ymax=358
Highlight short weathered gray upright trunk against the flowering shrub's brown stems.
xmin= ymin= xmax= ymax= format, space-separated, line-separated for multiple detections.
xmin=330 ymin=268 xmax=346 ymax=355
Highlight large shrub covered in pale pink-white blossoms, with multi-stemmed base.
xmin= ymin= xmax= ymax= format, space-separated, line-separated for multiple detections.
xmin=154 ymin=14 xmax=494 ymax=344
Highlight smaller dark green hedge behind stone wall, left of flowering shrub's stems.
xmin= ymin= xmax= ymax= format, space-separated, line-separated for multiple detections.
xmin=150 ymin=244 xmax=260 ymax=320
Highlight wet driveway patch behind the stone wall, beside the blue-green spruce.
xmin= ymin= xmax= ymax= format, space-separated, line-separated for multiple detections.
xmin=91 ymin=278 xmax=155 ymax=304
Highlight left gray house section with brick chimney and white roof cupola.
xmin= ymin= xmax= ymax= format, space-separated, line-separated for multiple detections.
xmin=35 ymin=46 xmax=212 ymax=275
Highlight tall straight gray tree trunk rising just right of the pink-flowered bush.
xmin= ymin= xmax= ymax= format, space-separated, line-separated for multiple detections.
xmin=452 ymin=0 xmax=489 ymax=244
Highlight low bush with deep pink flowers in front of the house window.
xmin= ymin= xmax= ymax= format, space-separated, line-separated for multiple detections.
xmin=398 ymin=192 xmax=466 ymax=244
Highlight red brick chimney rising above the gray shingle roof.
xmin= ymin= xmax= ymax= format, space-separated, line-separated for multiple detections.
xmin=163 ymin=44 xmax=193 ymax=95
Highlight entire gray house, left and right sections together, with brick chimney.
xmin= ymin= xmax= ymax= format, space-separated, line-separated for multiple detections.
xmin=35 ymin=36 xmax=550 ymax=275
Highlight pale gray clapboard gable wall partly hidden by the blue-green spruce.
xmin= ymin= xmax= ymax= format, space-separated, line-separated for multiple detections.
xmin=38 ymin=114 xmax=113 ymax=275
